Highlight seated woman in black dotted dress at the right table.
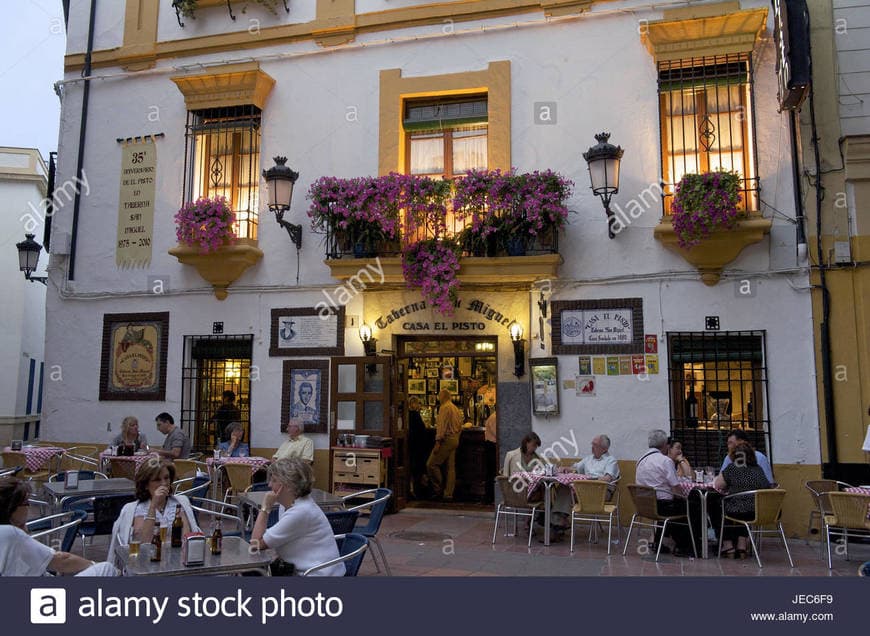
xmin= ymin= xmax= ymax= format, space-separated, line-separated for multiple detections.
xmin=714 ymin=442 xmax=770 ymax=559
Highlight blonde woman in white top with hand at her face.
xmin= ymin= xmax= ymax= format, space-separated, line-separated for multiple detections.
xmin=251 ymin=457 xmax=345 ymax=576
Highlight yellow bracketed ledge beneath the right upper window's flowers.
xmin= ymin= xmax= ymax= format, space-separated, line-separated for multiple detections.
xmin=653 ymin=214 xmax=773 ymax=286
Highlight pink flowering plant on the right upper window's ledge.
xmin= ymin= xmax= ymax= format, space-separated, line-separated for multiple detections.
xmin=671 ymin=170 xmax=741 ymax=248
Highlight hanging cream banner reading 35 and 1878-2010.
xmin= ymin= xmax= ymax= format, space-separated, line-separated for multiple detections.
xmin=115 ymin=139 xmax=157 ymax=267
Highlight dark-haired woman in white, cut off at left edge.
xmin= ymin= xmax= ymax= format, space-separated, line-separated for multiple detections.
xmin=0 ymin=477 xmax=118 ymax=576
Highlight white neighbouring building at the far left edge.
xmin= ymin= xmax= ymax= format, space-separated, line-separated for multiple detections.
xmin=0 ymin=147 xmax=48 ymax=446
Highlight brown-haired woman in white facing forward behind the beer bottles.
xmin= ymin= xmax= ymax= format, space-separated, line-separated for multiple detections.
xmin=107 ymin=458 xmax=200 ymax=563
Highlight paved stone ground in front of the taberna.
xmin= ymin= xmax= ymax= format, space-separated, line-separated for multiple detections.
xmin=360 ymin=508 xmax=870 ymax=576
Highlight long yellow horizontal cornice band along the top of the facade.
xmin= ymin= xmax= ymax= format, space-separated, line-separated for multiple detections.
xmin=64 ymin=0 xmax=615 ymax=72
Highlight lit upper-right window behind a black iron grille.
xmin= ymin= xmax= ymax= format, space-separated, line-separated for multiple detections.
xmin=658 ymin=53 xmax=758 ymax=214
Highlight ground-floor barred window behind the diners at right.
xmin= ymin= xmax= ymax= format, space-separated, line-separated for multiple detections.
xmin=668 ymin=331 xmax=770 ymax=468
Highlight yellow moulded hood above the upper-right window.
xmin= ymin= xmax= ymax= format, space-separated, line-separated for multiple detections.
xmin=640 ymin=3 xmax=767 ymax=62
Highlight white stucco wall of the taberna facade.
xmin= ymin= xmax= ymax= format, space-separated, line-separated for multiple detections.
xmin=46 ymin=0 xmax=819 ymax=463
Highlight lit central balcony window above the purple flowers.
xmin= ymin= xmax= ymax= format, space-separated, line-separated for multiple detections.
xmin=402 ymin=95 xmax=489 ymax=240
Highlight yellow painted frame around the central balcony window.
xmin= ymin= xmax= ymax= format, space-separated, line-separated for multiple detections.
xmin=378 ymin=61 xmax=511 ymax=175
